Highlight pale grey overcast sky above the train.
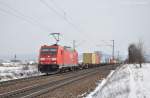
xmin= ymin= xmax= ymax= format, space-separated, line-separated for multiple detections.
xmin=0 ymin=0 xmax=150 ymax=58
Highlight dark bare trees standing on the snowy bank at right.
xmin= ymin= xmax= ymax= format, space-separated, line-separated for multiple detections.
xmin=128 ymin=41 xmax=145 ymax=67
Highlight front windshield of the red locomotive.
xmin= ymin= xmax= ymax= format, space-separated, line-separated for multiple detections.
xmin=41 ymin=48 xmax=57 ymax=55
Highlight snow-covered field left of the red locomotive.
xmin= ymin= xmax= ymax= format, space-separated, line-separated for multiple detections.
xmin=0 ymin=65 xmax=41 ymax=82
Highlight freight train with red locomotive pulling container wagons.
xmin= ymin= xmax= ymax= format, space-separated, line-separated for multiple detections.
xmin=38 ymin=44 xmax=117 ymax=74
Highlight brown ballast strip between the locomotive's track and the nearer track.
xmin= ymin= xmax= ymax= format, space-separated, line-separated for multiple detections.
xmin=0 ymin=71 xmax=84 ymax=94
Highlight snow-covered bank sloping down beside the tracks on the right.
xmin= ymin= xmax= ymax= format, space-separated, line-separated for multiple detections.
xmin=86 ymin=64 xmax=150 ymax=98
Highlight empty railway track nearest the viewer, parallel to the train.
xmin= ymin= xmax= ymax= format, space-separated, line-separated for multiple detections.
xmin=0 ymin=66 xmax=118 ymax=98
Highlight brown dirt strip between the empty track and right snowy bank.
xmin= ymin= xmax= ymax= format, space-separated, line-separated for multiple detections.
xmin=38 ymin=64 xmax=117 ymax=98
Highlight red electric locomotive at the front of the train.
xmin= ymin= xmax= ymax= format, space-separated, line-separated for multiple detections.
xmin=38 ymin=44 xmax=78 ymax=73
